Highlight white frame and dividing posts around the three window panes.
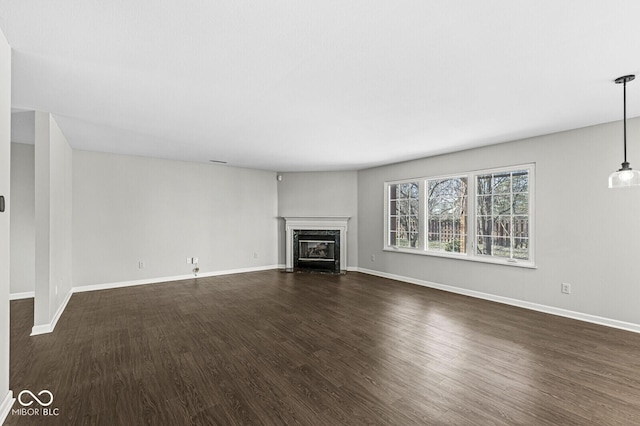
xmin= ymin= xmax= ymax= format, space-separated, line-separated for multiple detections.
xmin=382 ymin=163 xmax=536 ymax=268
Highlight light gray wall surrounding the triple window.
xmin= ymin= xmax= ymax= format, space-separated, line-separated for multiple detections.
xmin=358 ymin=119 xmax=640 ymax=324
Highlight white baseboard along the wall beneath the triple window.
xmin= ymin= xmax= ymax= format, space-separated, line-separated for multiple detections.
xmin=358 ymin=268 xmax=640 ymax=333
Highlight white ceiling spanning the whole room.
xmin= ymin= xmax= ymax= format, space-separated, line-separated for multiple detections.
xmin=0 ymin=0 xmax=640 ymax=171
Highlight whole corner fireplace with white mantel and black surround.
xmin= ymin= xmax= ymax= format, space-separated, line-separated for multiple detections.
xmin=284 ymin=216 xmax=349 ymax=274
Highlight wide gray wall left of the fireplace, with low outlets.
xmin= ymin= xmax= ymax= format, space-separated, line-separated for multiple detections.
xmin=73 ymin=151 xmax=277 ymax=286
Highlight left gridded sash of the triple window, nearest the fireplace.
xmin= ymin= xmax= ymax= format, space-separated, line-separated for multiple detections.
xmin=387 ymin=182 xmax=420 ymax=248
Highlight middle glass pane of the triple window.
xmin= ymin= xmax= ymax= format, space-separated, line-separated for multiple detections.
xmin=427 ymin=177 xmax=467 ymax=253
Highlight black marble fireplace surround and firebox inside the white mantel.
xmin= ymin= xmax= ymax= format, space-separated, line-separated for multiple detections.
xmin=293 ymin=229 xmax=340 ymax=273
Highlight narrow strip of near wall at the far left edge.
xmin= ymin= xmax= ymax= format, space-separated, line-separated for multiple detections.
xmin=0 ymin=31 xmax=13 ymax=422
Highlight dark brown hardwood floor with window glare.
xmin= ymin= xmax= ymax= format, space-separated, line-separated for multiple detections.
xmin=5 ymin=271 xmax=640 ymax=426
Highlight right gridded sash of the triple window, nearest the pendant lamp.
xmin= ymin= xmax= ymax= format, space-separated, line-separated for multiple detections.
xmin=476 ymin=170 xmax=529 ymax=260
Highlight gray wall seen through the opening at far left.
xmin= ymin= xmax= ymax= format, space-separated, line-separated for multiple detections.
xmin=11 ymin=141 xmax=36 ymax=294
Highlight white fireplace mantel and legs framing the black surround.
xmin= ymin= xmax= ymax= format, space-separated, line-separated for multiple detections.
xmin=283 ymin=216 xmax=351 ymax=271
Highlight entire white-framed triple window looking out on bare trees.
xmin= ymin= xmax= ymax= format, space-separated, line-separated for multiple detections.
xmin=384 ymin=164 xmax=534 ymax=267
